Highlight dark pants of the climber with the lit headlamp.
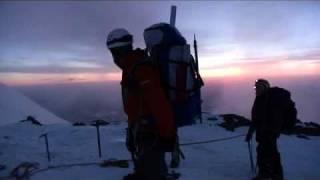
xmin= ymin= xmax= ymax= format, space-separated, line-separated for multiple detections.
xmin=257 ymin=138 xmax=283 ymax=180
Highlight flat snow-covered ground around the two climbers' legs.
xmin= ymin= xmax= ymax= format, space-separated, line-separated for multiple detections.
xmin=0 ymin=114 xmax=320 ymax=180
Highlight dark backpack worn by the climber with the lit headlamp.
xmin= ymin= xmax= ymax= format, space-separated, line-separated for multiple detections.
xmin=270 ymin=87 xmax=297 ymax=131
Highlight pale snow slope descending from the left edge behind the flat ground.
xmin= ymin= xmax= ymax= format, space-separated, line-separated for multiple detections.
xmin=0 ymin=84 xmax=67 ymax=125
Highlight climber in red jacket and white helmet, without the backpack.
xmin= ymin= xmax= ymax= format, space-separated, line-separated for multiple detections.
xmin=107 ymin=29 xmax=176 ymax=180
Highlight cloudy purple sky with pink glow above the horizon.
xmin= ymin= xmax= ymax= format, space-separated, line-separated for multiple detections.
xmin=0 ymin=1 xmax=320 ymax=85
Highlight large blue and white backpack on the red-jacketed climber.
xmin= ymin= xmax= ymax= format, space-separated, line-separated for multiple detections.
xmin=144 ymin=23 xmax=203 ymax=127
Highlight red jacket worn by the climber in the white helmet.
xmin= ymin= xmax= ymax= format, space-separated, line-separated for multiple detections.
xmin=121 ymin=49 xmax=175 ymax=138
